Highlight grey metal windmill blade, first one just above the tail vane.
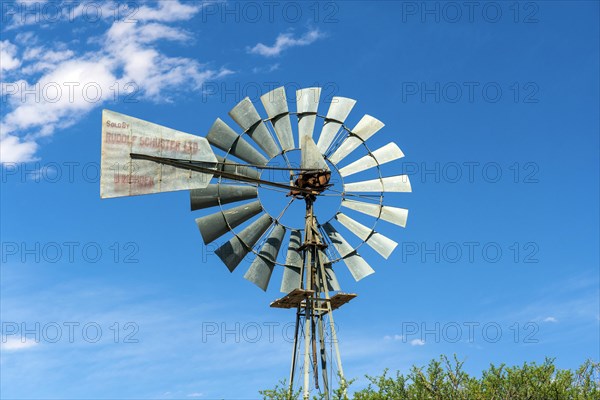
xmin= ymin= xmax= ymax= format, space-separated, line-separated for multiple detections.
xmin=206 ymin=118 xmax=268 ymax=165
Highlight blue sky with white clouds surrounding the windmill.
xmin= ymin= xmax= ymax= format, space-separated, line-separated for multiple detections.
xmin=0 ymin=1 xmax=600 ymax=399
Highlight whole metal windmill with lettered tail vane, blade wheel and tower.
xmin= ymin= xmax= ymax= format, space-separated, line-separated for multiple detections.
xmin=100 ymin=87 xmax=411 ymax=399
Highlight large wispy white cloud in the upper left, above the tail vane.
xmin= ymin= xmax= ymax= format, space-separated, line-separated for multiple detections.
xmin=0 ymin=1 xmax=232 ymax=163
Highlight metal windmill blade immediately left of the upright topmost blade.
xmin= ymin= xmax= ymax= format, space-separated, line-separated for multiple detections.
xmin=260 ymin=86 xmax=296 ymax=151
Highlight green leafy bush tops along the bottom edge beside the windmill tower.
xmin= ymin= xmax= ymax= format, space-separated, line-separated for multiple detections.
xmin=259 ymin=355 xmax=600 ymax=400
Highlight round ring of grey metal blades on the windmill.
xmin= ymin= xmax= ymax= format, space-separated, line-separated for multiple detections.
xmin=190 ymin=87 xmax=411 ymax=284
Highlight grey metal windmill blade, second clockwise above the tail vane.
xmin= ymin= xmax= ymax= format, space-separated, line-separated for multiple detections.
xmin=229 ymin=97 xmax=279 ymax=158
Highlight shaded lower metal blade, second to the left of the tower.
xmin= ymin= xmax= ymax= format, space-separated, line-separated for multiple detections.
xmin=244 ymin=224 xmax=285 ymax=292
